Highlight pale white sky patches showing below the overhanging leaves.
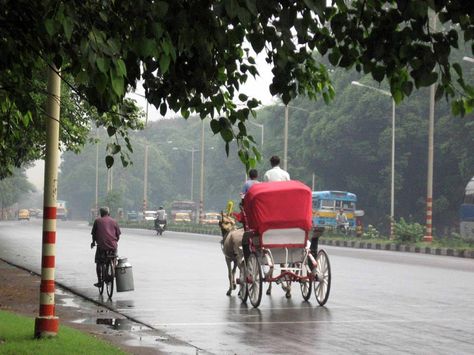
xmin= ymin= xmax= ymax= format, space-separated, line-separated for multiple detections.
xmin=26 ymin=55 xmax=275 ymax=191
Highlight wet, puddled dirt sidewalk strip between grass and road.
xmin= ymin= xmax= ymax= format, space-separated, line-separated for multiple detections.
xmin=0 ymin=259 xmax=179 ymax=355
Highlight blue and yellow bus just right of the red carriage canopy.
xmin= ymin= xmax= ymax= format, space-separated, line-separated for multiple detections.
xmin=313 ymin=191 xmax=357 ymax=229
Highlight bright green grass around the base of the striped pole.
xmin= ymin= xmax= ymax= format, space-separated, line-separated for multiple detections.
xmin=0 ymin=311 xmax=126 ymax=355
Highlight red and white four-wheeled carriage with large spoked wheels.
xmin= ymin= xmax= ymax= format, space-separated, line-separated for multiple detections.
xmin=237 ymin=181 xmax=331 ymax=307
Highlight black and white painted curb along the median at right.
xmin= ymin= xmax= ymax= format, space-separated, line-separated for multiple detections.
xmin=319 ymin=238 xmax=474 ymax=259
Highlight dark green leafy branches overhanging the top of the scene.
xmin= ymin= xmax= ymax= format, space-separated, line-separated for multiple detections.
xmin=0 ymin=0 xmax=474 ymax=178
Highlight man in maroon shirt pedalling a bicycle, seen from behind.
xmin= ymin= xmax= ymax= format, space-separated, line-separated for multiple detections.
xmin=91 ymin=207 xmax=121 ymax=287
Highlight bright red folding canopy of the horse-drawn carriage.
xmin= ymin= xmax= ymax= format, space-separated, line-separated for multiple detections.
xmin=244 ymin=181 xmax=312 ymax=234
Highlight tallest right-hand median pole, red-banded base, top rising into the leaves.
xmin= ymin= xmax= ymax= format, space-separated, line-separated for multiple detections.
xmin=423 ymin=13 xmax=436 ymax=242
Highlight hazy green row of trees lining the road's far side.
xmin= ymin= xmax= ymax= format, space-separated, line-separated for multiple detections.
xmin=59 ymin=63 xmax=474 ymax=236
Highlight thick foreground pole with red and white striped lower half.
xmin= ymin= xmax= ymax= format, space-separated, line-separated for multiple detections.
xmin=35 ymin=66 xmax=61 ymax=338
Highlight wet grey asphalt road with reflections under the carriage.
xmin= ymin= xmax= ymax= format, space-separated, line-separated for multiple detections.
xmin=0 ymin=220 xmax=474 ymax=354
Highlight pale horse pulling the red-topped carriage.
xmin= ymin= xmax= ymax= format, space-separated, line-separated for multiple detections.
xmin=219 ymin=212 xmax=244 ymax=296
